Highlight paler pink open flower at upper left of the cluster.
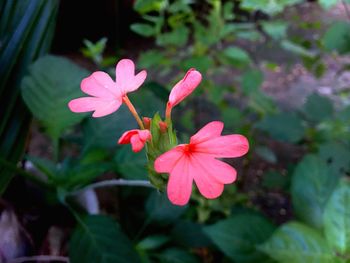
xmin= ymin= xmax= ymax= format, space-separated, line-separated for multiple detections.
xmin=68 ymin=59 xmax=147 ymax=117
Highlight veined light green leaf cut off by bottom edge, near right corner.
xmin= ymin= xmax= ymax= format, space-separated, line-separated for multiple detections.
xmin=259 ymin=222 xmax=336 ymax=263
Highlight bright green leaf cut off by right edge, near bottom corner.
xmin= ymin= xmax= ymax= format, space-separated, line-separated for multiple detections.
xmin=323 ymin=181 xmax=350 ymax=255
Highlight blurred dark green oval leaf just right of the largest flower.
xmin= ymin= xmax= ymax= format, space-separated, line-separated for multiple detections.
xmin=256 ymin=113 xmax=305 ymax=143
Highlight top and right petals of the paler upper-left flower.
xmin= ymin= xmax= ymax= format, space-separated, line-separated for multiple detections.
xmin=116 ymin=59 xmax=147 ymax=95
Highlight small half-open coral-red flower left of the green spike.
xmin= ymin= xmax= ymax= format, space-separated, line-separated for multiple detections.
xmin=118 ymin=129 xmax=152 ymax=152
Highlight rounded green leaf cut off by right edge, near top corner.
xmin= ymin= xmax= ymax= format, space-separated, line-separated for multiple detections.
xmin=322 ymin=21 xmax=350 ymax=54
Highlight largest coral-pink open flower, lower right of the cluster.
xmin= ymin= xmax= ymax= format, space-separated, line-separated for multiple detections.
xmin=154 ymin=121 xmax=249 ymax=205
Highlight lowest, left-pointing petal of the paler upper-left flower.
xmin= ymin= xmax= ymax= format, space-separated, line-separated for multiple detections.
xmin=68 ymin=97 xmax=121 ymax=117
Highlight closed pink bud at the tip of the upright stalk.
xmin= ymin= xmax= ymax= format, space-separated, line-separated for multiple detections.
xmin=169 ymin=69 xmax=202 ymax=107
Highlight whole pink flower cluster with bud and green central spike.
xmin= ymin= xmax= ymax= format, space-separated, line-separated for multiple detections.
xmin=68 ymin=59 xmax=249 ymax=205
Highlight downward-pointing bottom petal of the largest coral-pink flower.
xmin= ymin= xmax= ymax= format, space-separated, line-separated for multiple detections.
xmin=167 ymin=156 xmax=193 ymax=206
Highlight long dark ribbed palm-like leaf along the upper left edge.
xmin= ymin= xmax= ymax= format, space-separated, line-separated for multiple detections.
xmin=0 ymin=0 xmax=58 ymax=194
